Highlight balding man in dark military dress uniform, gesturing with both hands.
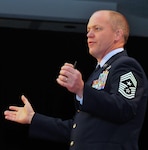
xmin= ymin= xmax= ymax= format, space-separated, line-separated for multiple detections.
xmin=4 ymin=10 xmax=148 ymax=150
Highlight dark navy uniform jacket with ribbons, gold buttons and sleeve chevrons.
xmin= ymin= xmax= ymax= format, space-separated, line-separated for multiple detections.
xmin=29 ymin=50 xmax=148 ymax=150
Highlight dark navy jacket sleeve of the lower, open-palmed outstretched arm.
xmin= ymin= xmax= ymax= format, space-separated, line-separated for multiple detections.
xmin=29 ymin=113 xmax=72 ymax=143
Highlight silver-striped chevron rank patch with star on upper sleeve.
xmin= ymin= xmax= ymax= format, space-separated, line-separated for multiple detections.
xmin=118 ymin=72 xmax=137 ymax=99
